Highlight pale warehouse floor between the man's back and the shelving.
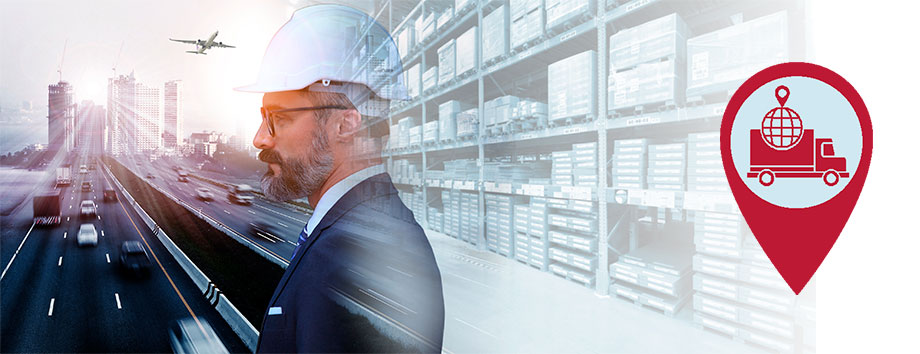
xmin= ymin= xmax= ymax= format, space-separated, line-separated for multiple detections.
xmin=425 ymin=230 xmax=762 ymax=353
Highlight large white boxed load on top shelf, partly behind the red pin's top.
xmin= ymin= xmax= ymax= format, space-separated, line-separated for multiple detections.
xmin=687 ymin=11 xmax=789 ymax=97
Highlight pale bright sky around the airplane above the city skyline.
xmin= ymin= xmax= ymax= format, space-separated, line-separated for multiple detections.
xmin=0 ymin=0 xmax=348 ymax=153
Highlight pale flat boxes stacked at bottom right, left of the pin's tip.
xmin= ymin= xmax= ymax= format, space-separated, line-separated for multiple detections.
xmin=693 ymin=212 xmax=796 ymax=352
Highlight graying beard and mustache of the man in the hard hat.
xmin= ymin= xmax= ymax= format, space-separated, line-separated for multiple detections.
xmin=262 ymin=134 xmax=333 ymax=201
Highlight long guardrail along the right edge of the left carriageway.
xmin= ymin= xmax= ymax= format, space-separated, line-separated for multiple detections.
xmin=102 ymin=163 xmax=259 ymax=352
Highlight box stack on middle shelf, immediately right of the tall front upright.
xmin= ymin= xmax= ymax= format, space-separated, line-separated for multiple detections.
xmin=610 ymin=139 xmax=648 ymax=189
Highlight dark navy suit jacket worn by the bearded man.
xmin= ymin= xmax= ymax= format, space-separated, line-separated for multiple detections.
xmin=257 ymin=173 xmax=444 ymax=352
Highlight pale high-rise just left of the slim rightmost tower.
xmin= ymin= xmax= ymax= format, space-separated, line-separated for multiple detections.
xmin=134 ymin=83 xmax=163 ymax=154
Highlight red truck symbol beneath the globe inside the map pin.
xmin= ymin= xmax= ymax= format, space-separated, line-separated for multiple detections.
xmin=747 ymin=129 xmax=850 ymax=186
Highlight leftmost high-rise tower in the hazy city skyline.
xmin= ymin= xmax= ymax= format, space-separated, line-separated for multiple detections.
xmin=48 ymin=81 xmax=74 ymax=153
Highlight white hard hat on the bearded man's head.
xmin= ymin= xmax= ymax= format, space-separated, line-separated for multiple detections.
xmin=236 ymin=4 xmax=408 ymax=105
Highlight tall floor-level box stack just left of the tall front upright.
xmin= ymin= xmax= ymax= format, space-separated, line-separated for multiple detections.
xmin=547 ymin=200 xmax=598 ymax=286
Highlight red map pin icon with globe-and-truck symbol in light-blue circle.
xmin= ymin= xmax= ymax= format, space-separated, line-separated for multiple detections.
xmin=720 ymin=62 xmax=872 ymax=294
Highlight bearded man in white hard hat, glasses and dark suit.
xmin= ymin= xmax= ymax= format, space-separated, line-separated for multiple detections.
xmin=238 ymin=4 xmax=444 ymax=352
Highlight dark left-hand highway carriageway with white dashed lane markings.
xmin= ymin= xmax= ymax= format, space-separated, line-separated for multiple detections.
xmin=0 ymin=163 xmax=248 ymax=352
